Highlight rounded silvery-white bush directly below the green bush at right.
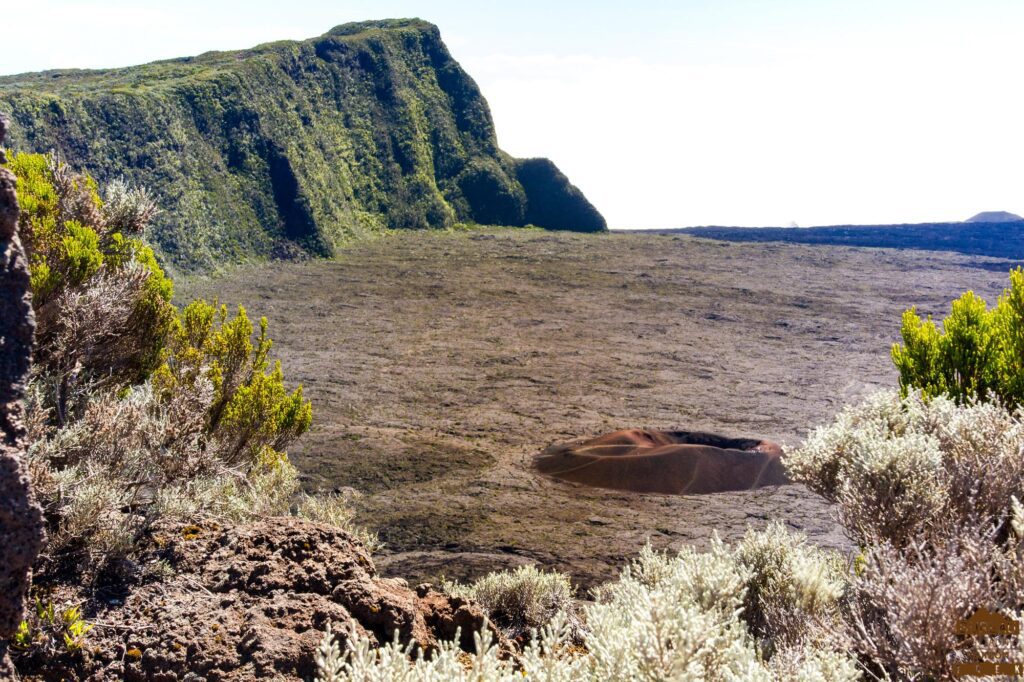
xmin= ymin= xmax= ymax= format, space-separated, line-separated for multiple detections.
xmin=786 ymin=391 xmax=1024 ymax=545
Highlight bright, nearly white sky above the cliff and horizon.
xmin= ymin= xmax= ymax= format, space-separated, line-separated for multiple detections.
xmin=6 ymin=0 xmax=1024 ymax=228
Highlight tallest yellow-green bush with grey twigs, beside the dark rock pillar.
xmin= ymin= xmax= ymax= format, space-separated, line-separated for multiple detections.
xmin=8 ymin=154 xmax=175 ymax=401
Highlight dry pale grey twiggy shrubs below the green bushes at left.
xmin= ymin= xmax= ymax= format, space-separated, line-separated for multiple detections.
xmin=27 ymin=379 xmax=379 ymax=569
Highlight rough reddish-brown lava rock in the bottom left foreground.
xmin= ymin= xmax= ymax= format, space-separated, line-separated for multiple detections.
xmin=17 ymin=517 xmax=497 ymax=681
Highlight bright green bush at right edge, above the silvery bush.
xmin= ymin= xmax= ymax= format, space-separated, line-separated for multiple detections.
xmin=892 ymin=267 xmax=1024 ymax=408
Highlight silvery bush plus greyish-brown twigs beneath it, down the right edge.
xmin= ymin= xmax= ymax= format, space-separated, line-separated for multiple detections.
xmin=788 ymin=391 xmax=1024 ymax=679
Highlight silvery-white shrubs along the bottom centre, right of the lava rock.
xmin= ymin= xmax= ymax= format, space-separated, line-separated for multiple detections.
xmin=318 ymin=526 xmax=858 ymax=681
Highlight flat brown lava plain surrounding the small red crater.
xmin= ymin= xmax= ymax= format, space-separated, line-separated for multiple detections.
xmin=178 ymin=229 xmax=1011 ymax=587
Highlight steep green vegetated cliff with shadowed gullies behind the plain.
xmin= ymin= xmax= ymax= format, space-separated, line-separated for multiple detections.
xmin=0 ymin=19 xmax=605 ymax=268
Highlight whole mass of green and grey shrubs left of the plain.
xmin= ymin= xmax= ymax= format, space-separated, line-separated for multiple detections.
xmin=1 ymin=154 xmax=385 ymax=602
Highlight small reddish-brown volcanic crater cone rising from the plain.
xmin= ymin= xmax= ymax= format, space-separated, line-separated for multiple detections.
xmin=534 ymin=429 xmax=790 ymax=495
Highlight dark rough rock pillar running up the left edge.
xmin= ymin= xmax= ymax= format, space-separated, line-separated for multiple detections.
xmin=0 ymin=118 xmax=43 ymax=678
